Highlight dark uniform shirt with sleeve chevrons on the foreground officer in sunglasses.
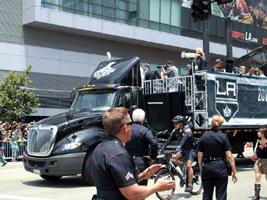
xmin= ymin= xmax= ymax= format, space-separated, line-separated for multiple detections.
xmin=92 ymin=136 xmax=138 ymax=200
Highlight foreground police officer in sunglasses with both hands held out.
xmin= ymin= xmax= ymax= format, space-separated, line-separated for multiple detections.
xmin=92 ymin=107 xmax=175 ymax=200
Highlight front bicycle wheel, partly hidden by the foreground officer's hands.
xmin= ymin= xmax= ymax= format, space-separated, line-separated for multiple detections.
xmin=154 ymin=169 xmax=175 ymax=200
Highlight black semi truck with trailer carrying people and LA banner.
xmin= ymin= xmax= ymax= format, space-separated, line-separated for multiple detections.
xmin=23 ymin=53 xmax=267 ymax=184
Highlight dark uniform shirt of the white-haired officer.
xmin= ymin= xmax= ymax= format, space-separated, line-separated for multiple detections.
xmin=125 ymin=122 xmax=158 ymax=160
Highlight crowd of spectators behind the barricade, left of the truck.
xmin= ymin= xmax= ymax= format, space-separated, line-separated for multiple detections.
xmin=0 ymin=121 xmax=33 ymax=161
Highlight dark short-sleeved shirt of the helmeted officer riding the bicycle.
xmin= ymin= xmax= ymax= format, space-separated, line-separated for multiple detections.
xmin=161 ymin=126 xmax=194 ymax=149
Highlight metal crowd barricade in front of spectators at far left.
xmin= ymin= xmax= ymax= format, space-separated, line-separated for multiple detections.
xmin=1 ymin=140 xmax=27 ymax=161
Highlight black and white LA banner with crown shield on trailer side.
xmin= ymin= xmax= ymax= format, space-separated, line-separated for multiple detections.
xmin=207 ymin=72 xmax=267 ymax=128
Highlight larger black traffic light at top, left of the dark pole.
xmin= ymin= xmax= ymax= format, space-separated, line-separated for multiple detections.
xmin=191 ymin=0 xmax=211 ymax=22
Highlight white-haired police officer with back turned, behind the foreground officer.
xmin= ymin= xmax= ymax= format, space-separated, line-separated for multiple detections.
xmin=125 ymin=108 xmax=158 ymax=185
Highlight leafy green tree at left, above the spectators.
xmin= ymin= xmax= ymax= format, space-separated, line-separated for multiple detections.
xmin=0 ymin=65 xmax=40 ymax=121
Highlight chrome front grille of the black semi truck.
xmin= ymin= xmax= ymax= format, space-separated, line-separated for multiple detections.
xmin=27 ymin=126 xmax=57 ymax=156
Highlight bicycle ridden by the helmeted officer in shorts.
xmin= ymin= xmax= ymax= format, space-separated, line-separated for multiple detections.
xmin=154 ymin=153 xmax=203 ymax=200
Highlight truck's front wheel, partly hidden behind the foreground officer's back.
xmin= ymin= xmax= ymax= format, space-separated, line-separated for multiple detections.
xmin=82 ymin=150 xmax=94 ymax=185
